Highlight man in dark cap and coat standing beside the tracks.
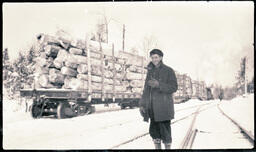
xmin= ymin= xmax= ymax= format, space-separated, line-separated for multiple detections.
xmin=139 ymin=49 xmax=178 ymax=149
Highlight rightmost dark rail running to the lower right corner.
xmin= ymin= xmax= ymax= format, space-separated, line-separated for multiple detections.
xmin=217 ymin=104 xmax=254 ymax=145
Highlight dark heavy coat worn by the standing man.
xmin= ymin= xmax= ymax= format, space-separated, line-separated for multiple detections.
xmin=139 ymin=62 xmax=178 ymax=121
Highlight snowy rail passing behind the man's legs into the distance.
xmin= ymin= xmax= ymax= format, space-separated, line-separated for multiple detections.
xmin=110 ymin=103 xmax=216 ymax=149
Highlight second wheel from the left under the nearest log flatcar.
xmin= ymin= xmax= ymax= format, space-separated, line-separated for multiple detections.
xmin=57 ymin=103 xmax=73 ymax=119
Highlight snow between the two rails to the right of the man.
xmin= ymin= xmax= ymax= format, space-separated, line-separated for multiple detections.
xmin=191 ymin=103 xmax=253 ymax=149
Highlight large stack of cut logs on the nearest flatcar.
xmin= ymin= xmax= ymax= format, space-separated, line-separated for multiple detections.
xmin=31 ymin=32 xmax=146 ymax=93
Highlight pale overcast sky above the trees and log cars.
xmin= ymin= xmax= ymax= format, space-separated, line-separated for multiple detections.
xmin=2 ymin=2 xmax=254 ymax=87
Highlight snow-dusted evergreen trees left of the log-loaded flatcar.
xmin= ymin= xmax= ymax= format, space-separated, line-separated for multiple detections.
xmin=3 ymin=46 xmax=35 ymax=99
